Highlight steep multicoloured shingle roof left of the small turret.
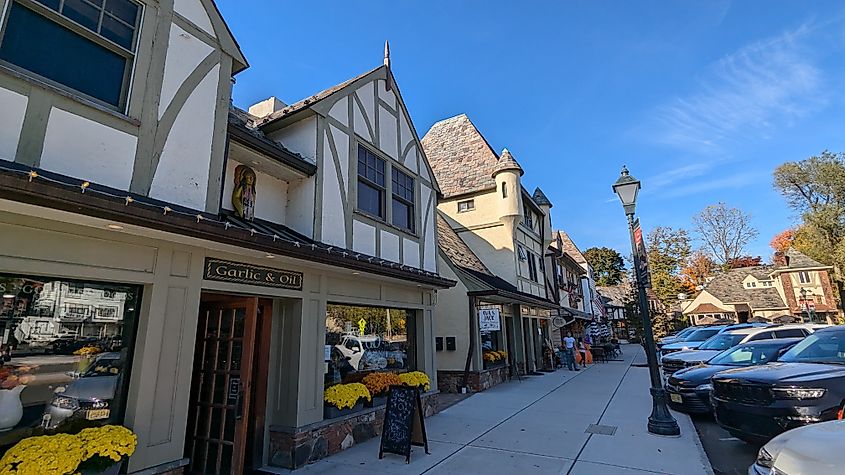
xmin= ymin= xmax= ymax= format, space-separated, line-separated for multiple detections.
xmin=421 ymin=114 xmax=499 ymax=198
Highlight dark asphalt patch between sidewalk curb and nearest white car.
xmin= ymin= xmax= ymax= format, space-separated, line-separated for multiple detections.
xmin=693 ymin=416 xmax=760 ymax=475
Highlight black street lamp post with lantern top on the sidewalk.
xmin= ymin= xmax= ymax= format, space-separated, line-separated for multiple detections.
xmin=613 ymin=167 xmax=681 ymax=435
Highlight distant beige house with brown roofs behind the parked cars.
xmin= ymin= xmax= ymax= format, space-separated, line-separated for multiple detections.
xmin=683 ymin=249 xmax=838 ymax=325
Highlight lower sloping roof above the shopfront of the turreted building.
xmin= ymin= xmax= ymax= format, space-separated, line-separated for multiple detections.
xmin=437 ymin=211 xmax=559 ymax=308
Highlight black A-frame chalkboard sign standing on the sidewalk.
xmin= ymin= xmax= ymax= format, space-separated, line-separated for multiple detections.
xmin=378 ymin=386 xmax=429 ymax=463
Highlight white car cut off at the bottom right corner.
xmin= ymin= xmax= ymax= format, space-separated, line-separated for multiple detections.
xmin=748 ymin=420 xmax=845 ymax=475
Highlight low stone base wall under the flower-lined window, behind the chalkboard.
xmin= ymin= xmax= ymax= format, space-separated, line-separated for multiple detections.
xmin=270 ymin=393 xmax=437 ymax=469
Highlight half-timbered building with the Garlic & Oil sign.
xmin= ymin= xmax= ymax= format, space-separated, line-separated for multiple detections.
xmin=0 ymin=0 xmax=454 ymax=474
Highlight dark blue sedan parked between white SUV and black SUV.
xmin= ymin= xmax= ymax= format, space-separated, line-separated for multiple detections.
xmin=666 ymin=338 xmax=801 ymax=414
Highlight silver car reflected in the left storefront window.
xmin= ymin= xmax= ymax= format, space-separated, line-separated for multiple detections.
xmin=42 ymin=352 xmax=125 ymax=429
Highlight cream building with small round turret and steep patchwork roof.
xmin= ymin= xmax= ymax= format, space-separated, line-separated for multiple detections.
xmin=422 ymin=114 xmax=558 ymax=391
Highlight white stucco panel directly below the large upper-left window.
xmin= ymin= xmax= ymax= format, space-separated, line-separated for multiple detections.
xmin=41 ymin=107 xmax=137 ymax=190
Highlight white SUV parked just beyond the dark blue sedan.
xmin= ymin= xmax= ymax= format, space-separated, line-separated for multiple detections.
xmin=661 ymin=324 xmax=814 ymax=376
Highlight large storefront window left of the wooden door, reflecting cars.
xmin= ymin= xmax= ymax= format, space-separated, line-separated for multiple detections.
xmin=0 ymin=274 xmax=141 ymax=454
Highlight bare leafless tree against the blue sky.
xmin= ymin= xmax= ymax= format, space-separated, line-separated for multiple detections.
xmin=692 ymin=202 xmax=758 ymax=268
